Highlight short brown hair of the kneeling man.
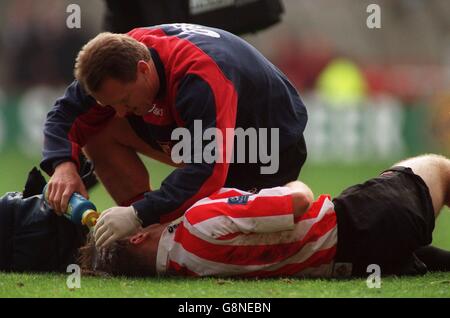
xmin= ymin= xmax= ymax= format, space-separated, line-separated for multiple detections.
xmin=74 ymin=32 xmax=150 ymax=94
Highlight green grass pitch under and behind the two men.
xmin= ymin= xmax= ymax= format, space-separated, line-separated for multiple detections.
xmin=0 ymin=151 xmax=450 ymax=298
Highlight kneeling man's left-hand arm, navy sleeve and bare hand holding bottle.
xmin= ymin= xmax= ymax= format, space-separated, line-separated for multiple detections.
xmin=41 ymin=81 xmax=114 ymax=214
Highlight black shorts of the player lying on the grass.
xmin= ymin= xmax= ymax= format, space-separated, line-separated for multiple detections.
xmin=333 ymin=167 xmax=435 ymax=276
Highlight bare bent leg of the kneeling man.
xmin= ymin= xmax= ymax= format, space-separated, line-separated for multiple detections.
xmin=83 ymin=117 xmax=182 ymax=204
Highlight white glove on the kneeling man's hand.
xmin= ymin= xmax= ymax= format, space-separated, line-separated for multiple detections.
xmin=94 ymin=206 xmax=141 ymax=248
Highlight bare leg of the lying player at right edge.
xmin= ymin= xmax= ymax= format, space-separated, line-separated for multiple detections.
xmin=395 ymin=154 xmax=450 ymax=217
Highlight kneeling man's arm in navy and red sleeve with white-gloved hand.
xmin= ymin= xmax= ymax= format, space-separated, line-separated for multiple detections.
xmin=94 ymin=74 xmax=237 ymax=247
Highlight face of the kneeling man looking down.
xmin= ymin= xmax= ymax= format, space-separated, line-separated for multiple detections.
xmin=92 ymin=61 xmax=159 ymax=117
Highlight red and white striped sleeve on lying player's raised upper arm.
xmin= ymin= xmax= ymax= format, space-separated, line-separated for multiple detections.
xmin=185 ymin=187 xmax=294 ymax=240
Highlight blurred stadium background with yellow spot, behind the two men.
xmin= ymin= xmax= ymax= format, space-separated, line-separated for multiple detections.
xmin=0 ymin=0 xmax=450 ymax=246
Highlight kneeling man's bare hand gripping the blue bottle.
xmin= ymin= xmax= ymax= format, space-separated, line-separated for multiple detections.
xmin=47 ymin=161 xmax=89 ymax=215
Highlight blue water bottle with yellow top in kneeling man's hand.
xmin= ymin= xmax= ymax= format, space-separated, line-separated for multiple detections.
xmin=42 ymin=185 xmax=100 ymax=228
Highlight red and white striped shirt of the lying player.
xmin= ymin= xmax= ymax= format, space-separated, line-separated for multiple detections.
xmin=156 ymin=187 xmax=337 ymax=277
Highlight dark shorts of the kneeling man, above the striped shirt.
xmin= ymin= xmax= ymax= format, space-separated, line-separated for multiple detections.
xmin=224 ymin=136 xmax=307 ymax=192
